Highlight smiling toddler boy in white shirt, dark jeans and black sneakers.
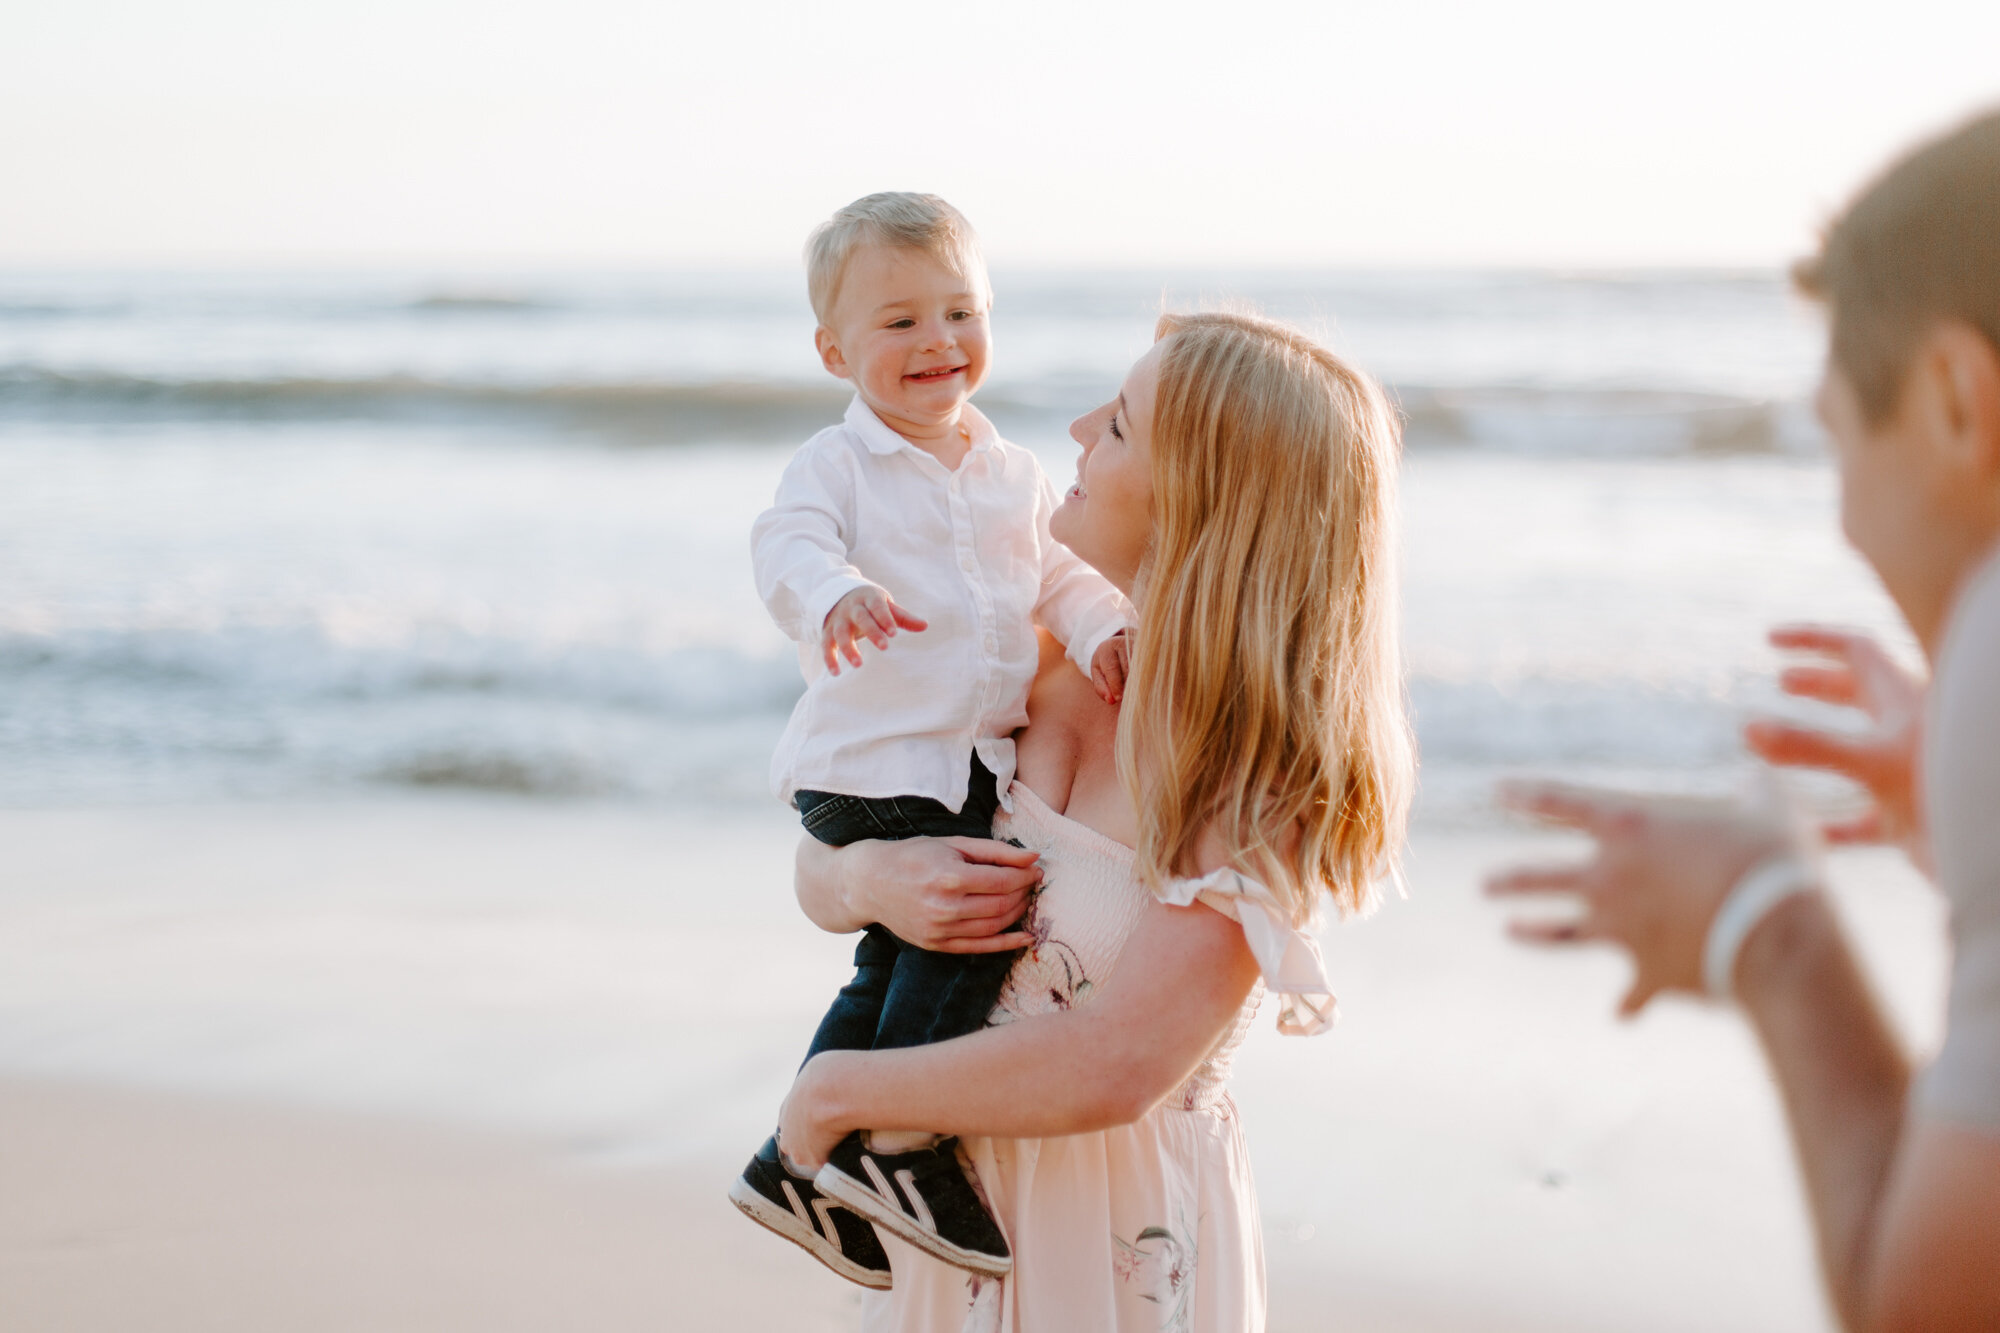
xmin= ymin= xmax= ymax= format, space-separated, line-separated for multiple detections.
xmin=730 ymin=192 xmax=1130 ymax=1287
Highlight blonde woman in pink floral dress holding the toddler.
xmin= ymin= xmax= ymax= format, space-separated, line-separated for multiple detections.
xmin=780 ymin=314 xmax=1412 ymax=1333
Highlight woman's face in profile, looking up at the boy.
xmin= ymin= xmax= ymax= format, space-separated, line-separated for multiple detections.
xmin=1048 ymin=346 xmax=1160 ymax=596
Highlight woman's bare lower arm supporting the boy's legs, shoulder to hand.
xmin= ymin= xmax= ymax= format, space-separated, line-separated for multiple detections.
xmin=780 ymin=892 xmax=1258 ymax=1167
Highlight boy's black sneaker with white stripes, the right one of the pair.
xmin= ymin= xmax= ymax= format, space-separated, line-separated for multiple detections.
xmin=812 ymin=1135 xmax=1014 ymax=1277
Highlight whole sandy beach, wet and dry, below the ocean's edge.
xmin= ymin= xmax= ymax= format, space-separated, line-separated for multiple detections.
xmin=0 ymin=799 xmax=1942 ymax=1333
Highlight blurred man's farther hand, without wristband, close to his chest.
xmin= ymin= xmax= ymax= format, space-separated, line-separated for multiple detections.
xmin=1744 ymin=624 xmax=1928 ymax=865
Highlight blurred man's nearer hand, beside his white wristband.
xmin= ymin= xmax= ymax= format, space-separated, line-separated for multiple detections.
xmin=1486 ymin=783 xmax=1804 ymax=1017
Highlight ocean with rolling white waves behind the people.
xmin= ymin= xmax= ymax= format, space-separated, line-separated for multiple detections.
xmin=0 ymin=270 xmax=1898 ymax=823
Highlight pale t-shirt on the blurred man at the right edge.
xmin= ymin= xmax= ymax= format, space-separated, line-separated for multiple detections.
xmin=1916 ymin=550 xmax=2000 ymax=1133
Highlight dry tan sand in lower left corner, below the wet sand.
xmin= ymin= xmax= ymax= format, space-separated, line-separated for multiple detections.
xmin=0 ymin=1081 xmax=858 ymax=1333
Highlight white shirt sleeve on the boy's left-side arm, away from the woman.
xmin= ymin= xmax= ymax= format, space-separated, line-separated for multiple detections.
xmin=750 ymin=442 xmax=876 ymax=642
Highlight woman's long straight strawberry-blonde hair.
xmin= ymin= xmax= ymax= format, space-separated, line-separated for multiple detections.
xmin=1118 ymin=314 xmax=1416 ymax=925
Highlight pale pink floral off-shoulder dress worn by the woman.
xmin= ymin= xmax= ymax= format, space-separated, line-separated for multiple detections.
xmin=862 ymin=783 xmax=1334 ymax=1333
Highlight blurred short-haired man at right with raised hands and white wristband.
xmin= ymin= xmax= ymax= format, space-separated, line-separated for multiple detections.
xmin=1488 ymin=114 xmax=2000 ymax=1329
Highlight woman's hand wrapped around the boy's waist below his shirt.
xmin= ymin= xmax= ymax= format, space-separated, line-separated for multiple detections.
xmin=840 ymin=839 xmax=1042 ymax=953
